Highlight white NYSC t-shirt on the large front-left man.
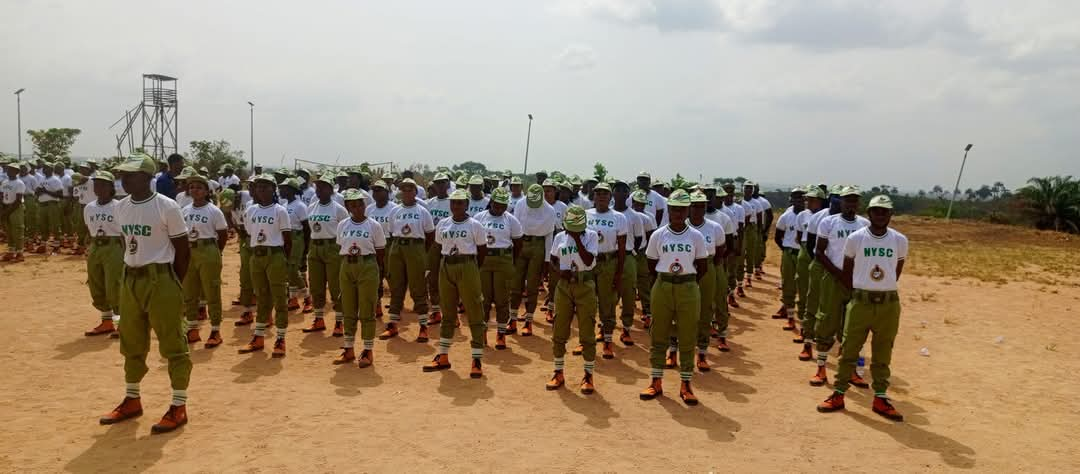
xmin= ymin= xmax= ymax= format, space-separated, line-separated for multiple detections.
xmin=116 ymin=192 xmax=188 ymax=267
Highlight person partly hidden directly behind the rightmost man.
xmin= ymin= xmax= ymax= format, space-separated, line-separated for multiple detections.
xmin=810 ymin=186 xmax=869 ymax=387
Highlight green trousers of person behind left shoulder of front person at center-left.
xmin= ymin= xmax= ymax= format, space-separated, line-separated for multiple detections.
xmin=387 ymin=239 xmax=425 ymax=321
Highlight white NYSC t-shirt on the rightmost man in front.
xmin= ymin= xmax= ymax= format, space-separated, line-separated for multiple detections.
xmin=843 ymin=227 xmax=907 ymax=292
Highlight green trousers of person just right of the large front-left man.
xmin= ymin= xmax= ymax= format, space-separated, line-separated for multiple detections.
xmin=184 ymin=239 xmax=221 ymax=326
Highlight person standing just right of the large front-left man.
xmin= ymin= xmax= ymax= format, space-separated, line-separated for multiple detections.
xmin=180 ymin=175 xmax=229 ymax=349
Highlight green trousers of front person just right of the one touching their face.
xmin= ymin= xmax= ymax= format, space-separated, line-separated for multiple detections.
xmin=649 ymin=277 xmax=701 ymax=374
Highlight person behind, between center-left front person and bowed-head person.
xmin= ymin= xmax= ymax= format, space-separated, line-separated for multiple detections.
xmin=473 ymin=188 xmax=520 ymax=350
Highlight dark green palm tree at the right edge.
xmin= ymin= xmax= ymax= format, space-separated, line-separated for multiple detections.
xmin=1018 ymin=176 xmax=1080 ymax=232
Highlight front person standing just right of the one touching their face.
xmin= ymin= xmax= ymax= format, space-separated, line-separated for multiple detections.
xmin=639 ymin=189 xmax=708 ymax=405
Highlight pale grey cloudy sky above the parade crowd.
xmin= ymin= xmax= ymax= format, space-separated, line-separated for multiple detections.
xmin=0 ymin=0 xmax=1080 ymax=189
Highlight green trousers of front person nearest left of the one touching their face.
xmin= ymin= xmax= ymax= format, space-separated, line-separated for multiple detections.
xmin=438 ymin=256 xmax=485 ymax=353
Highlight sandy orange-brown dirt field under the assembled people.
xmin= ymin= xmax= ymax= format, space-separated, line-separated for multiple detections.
xmin=0 ymin=219 xmax=1080 ymax=473
